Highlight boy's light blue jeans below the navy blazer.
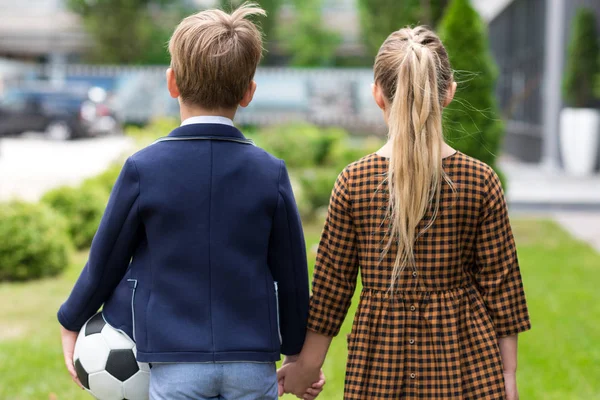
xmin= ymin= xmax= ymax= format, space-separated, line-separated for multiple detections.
xmin=150 ymin=362 xmax=277 ymax=400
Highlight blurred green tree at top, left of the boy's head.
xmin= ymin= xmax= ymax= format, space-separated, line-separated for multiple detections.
xmin=68 ymin=0 xmax=185 ymax=64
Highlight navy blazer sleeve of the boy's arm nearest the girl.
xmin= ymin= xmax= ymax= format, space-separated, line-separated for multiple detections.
xmin=268 ymin=162 xmax=309 ymax=355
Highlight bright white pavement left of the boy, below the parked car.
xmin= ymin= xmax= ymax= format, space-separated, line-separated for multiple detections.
xmin=0 ymin=136 xmax=134 ymax=201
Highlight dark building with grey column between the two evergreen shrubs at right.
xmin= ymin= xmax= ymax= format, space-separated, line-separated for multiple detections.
xmin=475 ymin=0 xmax=600 ymax=169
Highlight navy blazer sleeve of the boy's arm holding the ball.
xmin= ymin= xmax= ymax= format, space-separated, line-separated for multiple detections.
xmin=58 ymin=159 xmax=140 ymax=331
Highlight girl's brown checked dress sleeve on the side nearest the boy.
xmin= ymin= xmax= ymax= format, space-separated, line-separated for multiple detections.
xmin=308 ymin=170 xmax=358 ymax=336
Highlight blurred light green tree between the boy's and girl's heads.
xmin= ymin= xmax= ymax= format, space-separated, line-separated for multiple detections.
xmin=280 ymin=0 xmax=341 ymax=67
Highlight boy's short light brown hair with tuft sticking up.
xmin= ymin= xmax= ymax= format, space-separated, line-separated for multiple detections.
xmin=169 ymin=3 xmax=266 ymax=110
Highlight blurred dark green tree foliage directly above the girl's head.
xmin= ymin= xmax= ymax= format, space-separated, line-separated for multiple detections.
xmin=358 ymin=0 xmax=448 ymax=56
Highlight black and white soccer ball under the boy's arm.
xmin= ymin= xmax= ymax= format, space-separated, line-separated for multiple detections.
xmin=73 ymin=313 xmax=150 ymax=400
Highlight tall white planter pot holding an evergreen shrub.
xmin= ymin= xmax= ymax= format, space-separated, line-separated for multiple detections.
xmin=560 ymin=108 xmax=600 ymax=176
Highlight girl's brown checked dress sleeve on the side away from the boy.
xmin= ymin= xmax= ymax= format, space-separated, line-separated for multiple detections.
xmin=475 ymin=170 xmax=531 ymax=337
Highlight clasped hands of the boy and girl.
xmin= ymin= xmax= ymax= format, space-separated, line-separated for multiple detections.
xmin=277 ymin=360 xmax=325 ymax=400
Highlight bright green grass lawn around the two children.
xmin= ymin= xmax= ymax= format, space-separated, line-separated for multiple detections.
xmin=0 ymin=219 xmax=600 ymax=400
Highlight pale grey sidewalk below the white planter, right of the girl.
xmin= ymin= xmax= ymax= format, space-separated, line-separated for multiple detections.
xmin=499 ymin=158 xmax=600 ymax=252
